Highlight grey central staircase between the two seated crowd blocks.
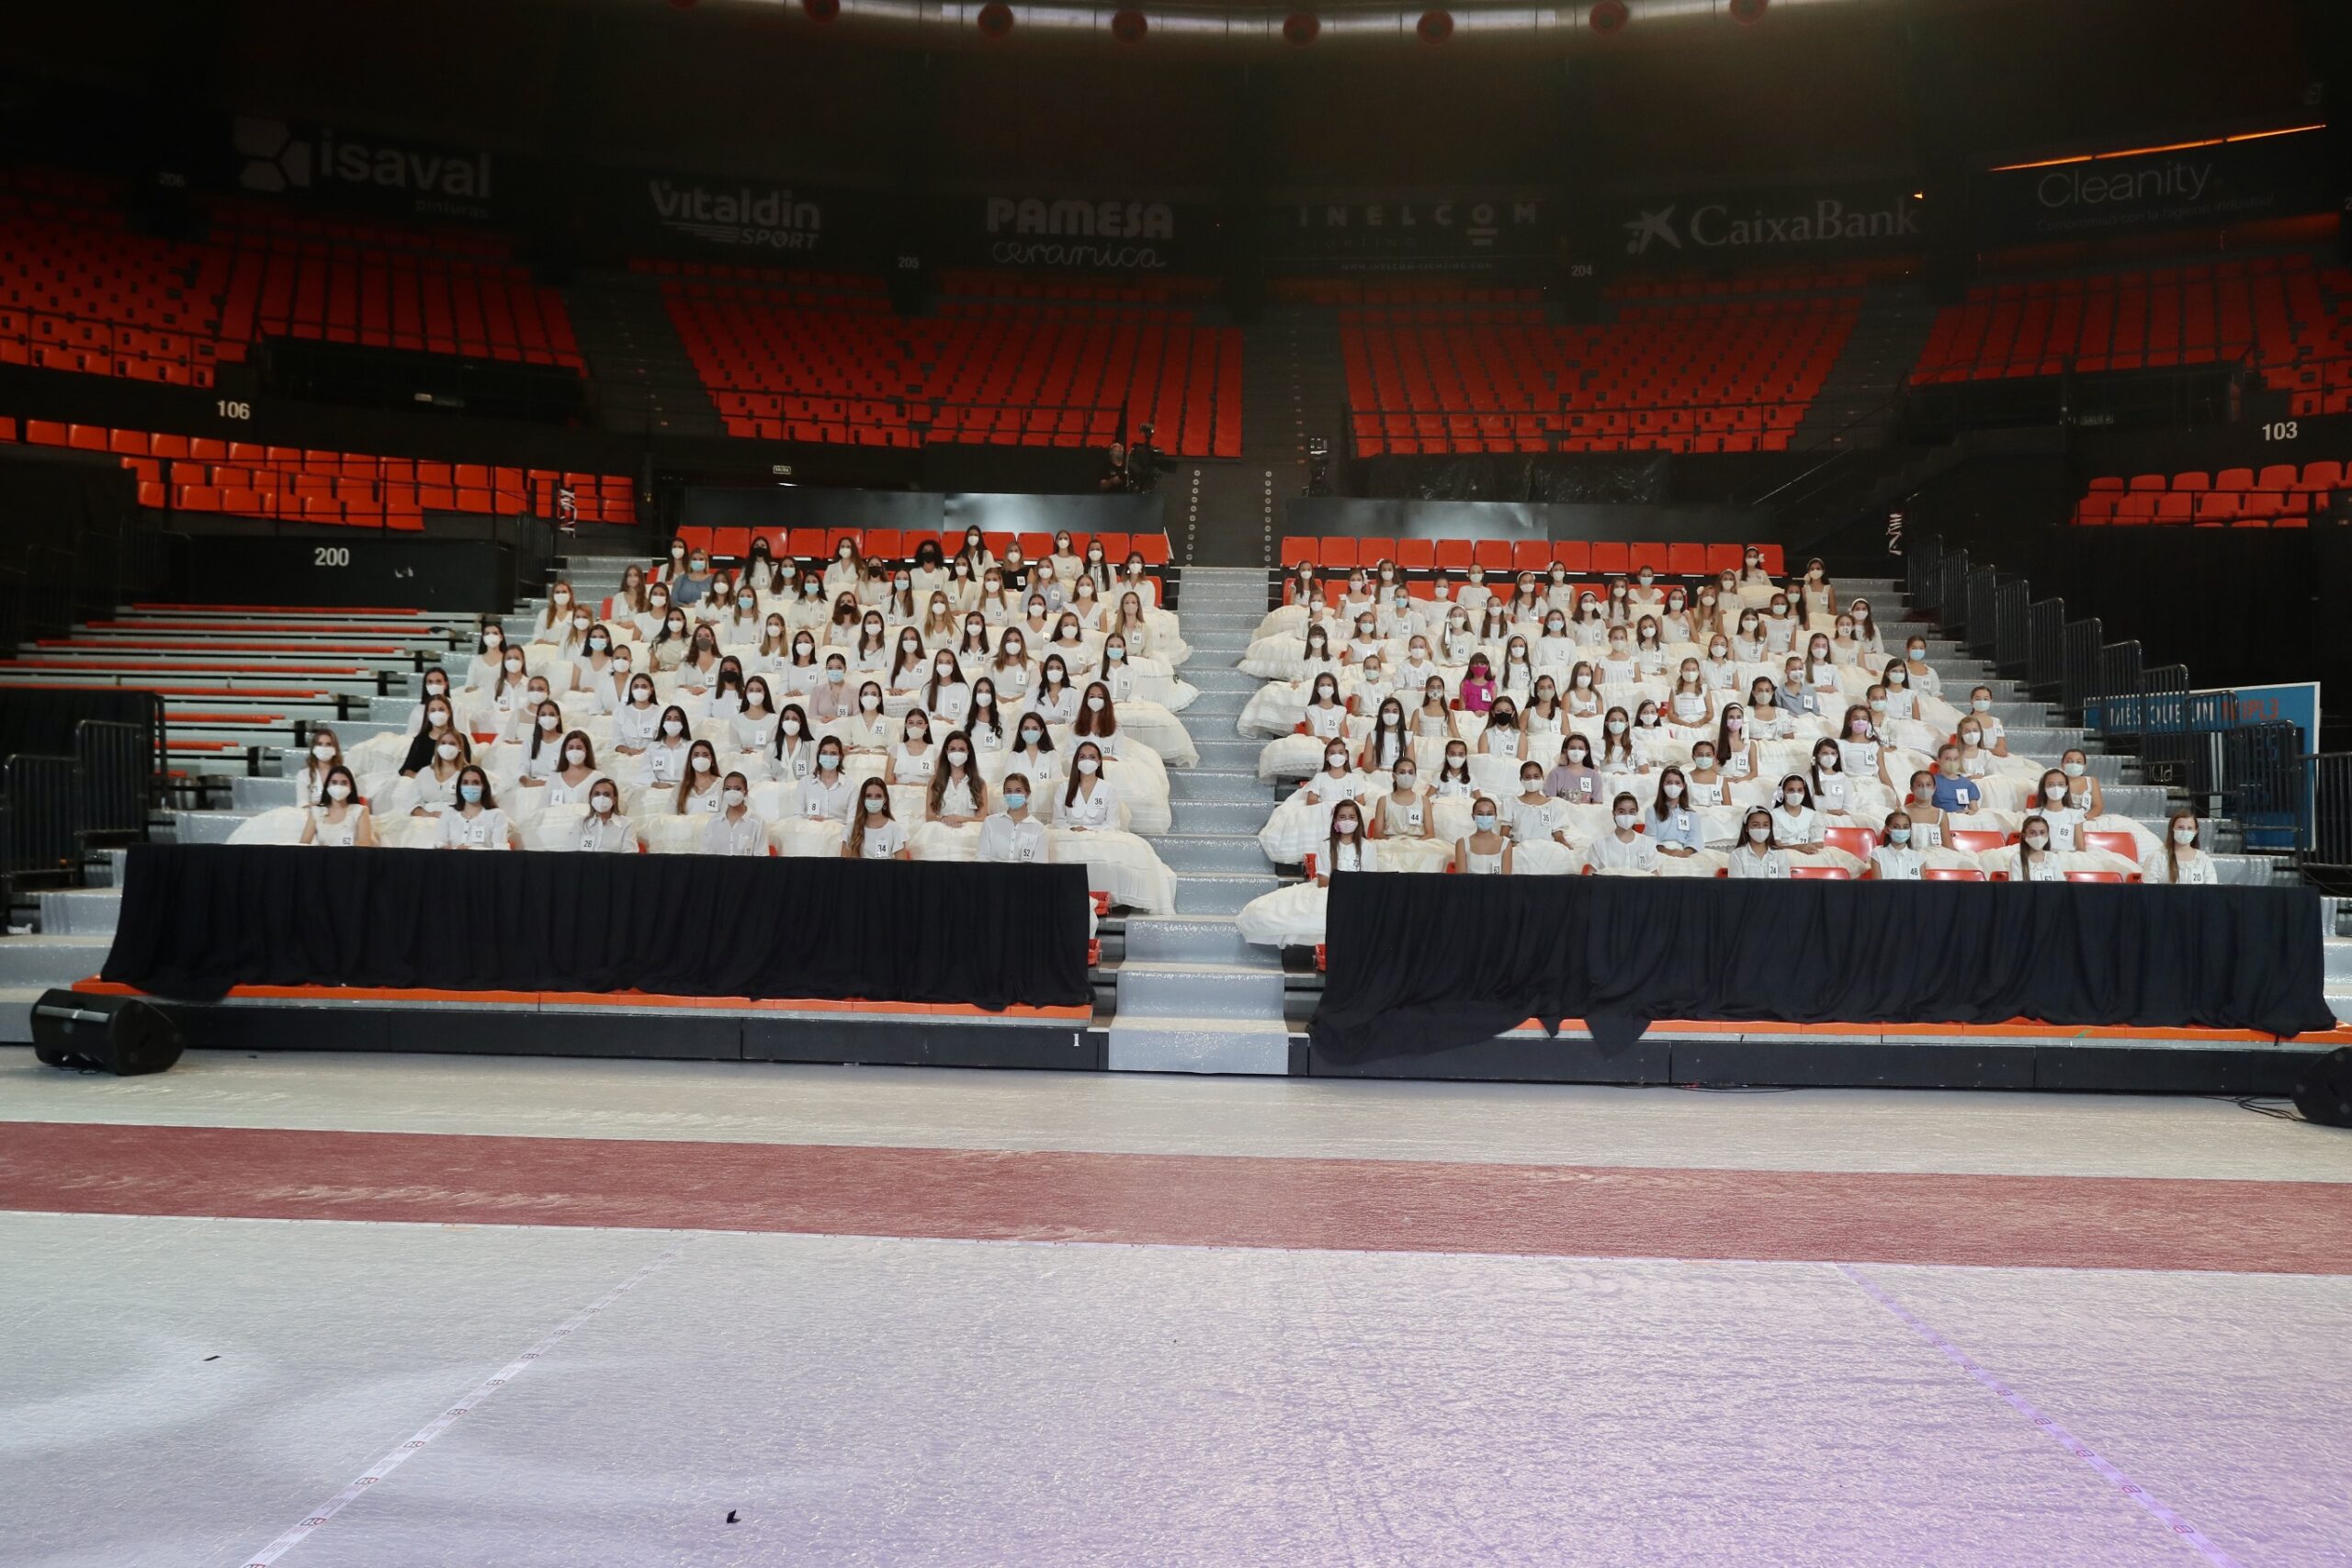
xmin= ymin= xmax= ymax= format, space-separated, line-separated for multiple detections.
xmin=1108 ymin=567 xmax=1289 ymax=1072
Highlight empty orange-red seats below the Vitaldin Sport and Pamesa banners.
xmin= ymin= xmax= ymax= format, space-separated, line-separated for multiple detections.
xmin=663 ymin=277 xmax=1242 ymax=456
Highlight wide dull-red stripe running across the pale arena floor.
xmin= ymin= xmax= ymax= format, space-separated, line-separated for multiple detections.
xmin=0 ymin=1122 xmax=2352 ymax=1274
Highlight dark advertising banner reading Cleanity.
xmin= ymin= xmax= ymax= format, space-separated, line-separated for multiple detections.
xmin=1969 ymin=131 xmax=2334 ymax=244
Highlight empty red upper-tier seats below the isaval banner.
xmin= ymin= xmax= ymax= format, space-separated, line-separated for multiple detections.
xmin=0 ymin=172 xmax=583 ymax=386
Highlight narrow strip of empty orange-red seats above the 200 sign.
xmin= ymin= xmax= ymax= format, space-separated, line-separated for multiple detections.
xmin=0 ymin=419 xmax=638 ymax=531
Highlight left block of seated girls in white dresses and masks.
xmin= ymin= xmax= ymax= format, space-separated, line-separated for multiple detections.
xmin=272 ymin=531 xmax=1181 ymax=874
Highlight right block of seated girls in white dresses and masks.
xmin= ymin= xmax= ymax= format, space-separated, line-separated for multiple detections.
xmin=1242 ymin=550 xmax=2218 ymax=959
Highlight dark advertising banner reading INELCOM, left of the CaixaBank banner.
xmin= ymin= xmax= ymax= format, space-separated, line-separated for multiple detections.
xmin=1265 ymin=195 xmax=1559 ymax=273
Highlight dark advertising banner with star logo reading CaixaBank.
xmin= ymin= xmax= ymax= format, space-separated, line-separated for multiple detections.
xmin=1613 ymin=181 xmax=1927 ymax=265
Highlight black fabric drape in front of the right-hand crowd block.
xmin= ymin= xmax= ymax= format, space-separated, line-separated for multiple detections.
xmin=1312 ymin=874 xmax=2335 ymax=1063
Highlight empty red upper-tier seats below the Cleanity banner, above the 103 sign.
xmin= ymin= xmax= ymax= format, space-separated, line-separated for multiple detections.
xmin=1910 ymin=254 xmax=2352 ymax=394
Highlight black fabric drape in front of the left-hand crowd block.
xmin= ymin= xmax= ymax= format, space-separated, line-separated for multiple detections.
xmin=101 ymin=844 xmax=1093 ymax=1009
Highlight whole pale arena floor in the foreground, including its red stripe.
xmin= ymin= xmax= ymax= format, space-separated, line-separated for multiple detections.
xmin=0 ymin=1051 xmax=2352 ymax=1568
